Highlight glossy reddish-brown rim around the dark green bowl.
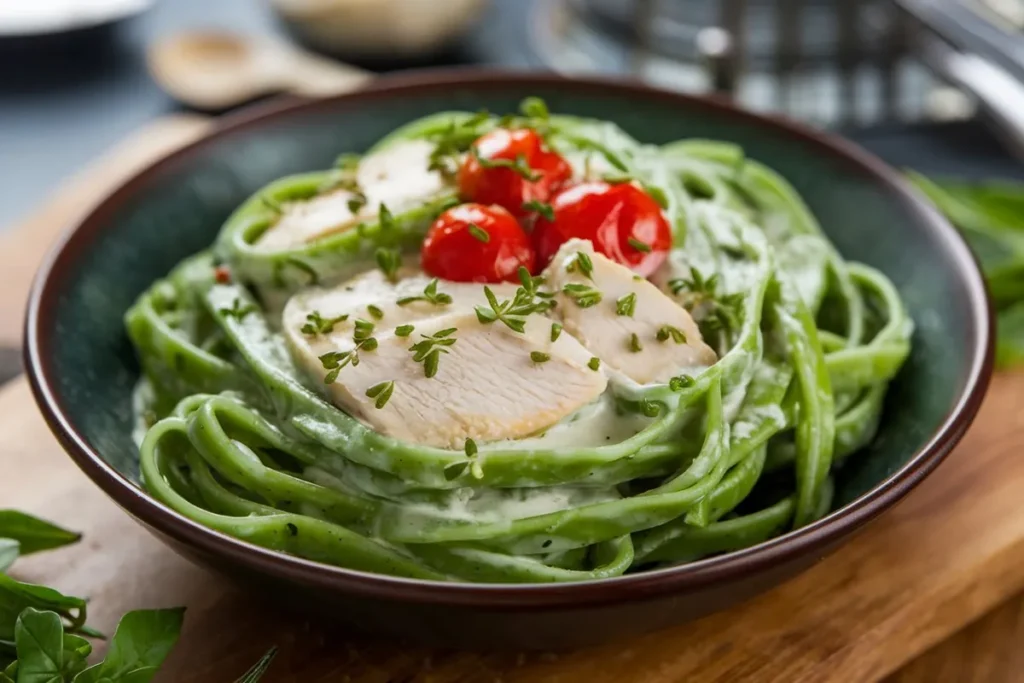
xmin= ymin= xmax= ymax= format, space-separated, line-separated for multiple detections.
xmin=24 ymin=69 xmax=994 ymax=610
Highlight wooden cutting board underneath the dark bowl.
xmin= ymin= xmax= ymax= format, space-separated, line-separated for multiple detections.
xmin=0 ymin=117 xmax=1024 ymax=683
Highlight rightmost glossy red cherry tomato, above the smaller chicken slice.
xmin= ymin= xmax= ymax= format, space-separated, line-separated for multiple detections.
xmin=534 ymin=181 xmax=672 ymax=278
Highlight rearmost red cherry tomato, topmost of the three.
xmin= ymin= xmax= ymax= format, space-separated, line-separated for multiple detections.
xmin=459 ymin=128 xmax=572 ymax=218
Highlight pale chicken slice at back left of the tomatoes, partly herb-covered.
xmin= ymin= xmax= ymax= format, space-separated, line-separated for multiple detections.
xmin=256 ymin=140 xmax=444 ymax=251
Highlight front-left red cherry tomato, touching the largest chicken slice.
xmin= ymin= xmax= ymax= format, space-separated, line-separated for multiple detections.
xmin=421 ymin=204 xmax=535 ymax=283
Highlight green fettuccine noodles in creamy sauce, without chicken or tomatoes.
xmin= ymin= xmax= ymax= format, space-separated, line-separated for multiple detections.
xmin=126 ymin=100 xmax=912 ymax=583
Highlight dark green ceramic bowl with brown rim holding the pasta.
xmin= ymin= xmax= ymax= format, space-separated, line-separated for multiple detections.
xmin=26 ymin=73 xmax=992 ymax=648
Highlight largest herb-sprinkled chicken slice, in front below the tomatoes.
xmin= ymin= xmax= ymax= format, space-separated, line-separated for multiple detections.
xmin=284 ymin=273 xmax=607 ymax=449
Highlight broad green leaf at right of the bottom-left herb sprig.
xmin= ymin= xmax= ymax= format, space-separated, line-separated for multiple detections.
xmin=74 ymin=607 xmax=185 ymax=683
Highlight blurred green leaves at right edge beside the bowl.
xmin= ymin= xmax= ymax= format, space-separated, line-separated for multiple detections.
xmin=908 ymin=171 xmax=1024 ymax=369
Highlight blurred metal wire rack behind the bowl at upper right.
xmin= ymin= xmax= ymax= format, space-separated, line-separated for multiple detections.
xmin=531 ymin=0 xmax=950 ymax=126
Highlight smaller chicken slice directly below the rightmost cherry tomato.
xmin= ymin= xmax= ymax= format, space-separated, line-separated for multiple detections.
xmin=545 ymin=240 xmax=717 ymax=384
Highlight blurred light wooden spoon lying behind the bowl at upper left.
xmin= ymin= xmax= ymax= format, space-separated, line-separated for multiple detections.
xmin=146 ymin=32 xmax=372 ymax=111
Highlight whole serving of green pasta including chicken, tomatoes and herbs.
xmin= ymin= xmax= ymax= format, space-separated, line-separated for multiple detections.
xmin=126 ymin=99 xmax=912 ymax=583
